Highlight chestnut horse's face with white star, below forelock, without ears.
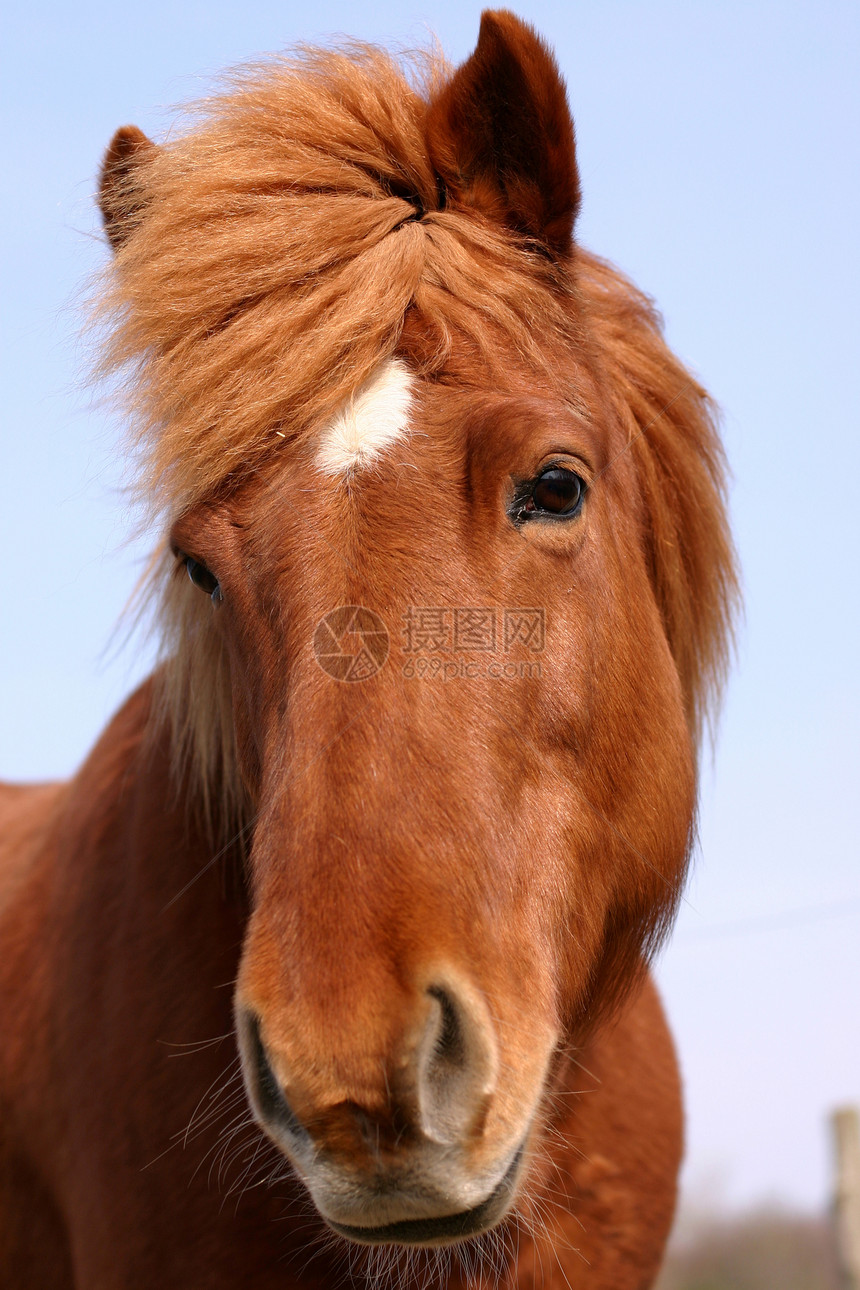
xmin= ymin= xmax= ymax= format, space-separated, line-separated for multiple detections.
xmin=173 ymin=355 xmax=694 ymax=1242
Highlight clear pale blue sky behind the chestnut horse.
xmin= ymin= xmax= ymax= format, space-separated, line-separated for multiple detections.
xmin=0 ymin=0 xmax=860 ymax=1205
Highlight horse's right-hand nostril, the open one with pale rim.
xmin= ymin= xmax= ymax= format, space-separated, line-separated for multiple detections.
xmin=418 ymin=983 xmax=498 ymax=1143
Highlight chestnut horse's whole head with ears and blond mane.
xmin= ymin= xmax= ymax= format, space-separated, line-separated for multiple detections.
xmin=102 ymin=13 xmax=731 ymax=1244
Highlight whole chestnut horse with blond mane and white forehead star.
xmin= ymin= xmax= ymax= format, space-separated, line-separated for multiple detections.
xmin=0 ymin=10 xmax=736 ymax=1290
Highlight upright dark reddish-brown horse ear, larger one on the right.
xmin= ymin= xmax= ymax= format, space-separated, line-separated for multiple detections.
xmin=427 ymin=9 xmax=579 ymax=255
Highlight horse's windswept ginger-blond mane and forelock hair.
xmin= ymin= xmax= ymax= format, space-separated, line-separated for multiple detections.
xmin=99 ymin=45 xmax=735 ymax=819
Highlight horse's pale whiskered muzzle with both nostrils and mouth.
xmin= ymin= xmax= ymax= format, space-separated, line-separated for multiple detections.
xmin=237 ymin=975 xmax=541 ymax=1245
